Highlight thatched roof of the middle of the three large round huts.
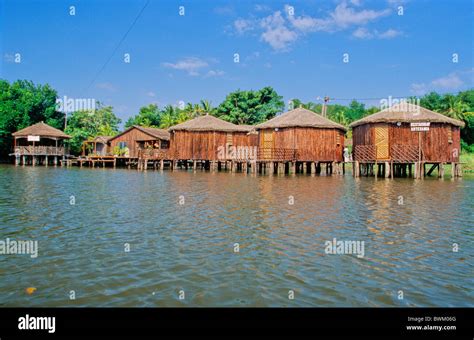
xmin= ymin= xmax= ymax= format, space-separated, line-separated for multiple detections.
xmin=255 ymin=107 xmax=347 ymax=131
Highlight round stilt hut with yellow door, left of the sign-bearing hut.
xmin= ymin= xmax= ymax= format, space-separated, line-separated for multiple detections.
xmin=255 ymin=108 xmax=346 ymax=174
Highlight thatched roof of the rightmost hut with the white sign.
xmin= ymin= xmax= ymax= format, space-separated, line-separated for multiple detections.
xmin=350 ymin=103 xmax=464 ymax=127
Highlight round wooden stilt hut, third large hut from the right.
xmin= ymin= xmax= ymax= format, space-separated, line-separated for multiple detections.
xmin=169 ymin=114 xmax=257 ymax=170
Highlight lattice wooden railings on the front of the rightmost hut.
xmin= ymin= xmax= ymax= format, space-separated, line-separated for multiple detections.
xmin=354 ymin=144 xmax=423 ymax=163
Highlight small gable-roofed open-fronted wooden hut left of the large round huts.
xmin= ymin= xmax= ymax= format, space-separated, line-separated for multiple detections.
xmin=108 ymin=125 xmax=170 ymax=160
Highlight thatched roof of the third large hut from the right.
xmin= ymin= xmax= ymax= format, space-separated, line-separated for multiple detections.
xmin=169 ymin=115 xmax=253 ymax=132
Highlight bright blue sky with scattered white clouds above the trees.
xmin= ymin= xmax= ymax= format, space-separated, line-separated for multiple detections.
xmin=0 ymin=0 xmax=474 ymax=125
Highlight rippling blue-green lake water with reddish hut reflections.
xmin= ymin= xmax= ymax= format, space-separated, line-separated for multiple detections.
xmin=0 ymin=165 xmax=474 ymax=307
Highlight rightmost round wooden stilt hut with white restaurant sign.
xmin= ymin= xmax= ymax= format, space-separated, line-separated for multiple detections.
xmin=350 ymin=102 xmax=464 ymax=178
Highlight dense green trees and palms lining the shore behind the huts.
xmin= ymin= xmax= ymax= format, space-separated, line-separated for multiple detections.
xmin=0 ymin=80 xmax=474 ymax=159
